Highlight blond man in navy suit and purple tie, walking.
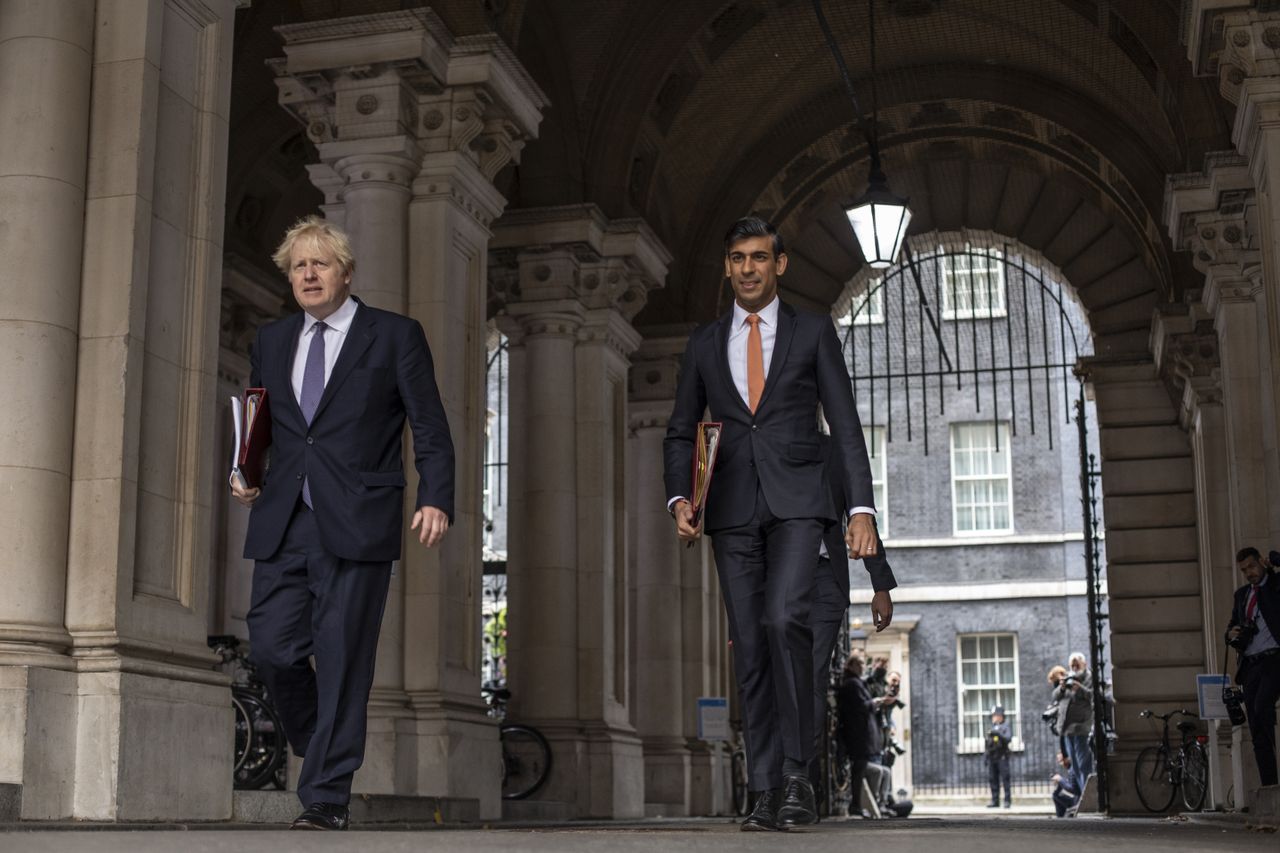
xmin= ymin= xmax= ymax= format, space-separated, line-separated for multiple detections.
xmin=232 ymin=216 xmax=453 ymax=830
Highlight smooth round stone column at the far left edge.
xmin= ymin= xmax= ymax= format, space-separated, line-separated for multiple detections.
xmin=0 ymin=0 xmax=93 ymax=820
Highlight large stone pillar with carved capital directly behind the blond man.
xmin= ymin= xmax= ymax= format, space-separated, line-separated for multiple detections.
xmin=274 ymin=9 xmax=547 ymax=818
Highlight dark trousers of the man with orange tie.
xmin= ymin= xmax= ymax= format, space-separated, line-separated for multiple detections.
xmin=712 ymin=481 xmax=823 ymax=790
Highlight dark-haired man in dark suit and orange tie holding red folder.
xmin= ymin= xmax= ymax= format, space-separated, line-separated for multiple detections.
xmin=663 ymin=216 xmax=876 ymax=830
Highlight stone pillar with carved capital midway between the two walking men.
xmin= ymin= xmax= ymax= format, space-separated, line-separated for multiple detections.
xmin=490 ymin=205 xmax=669 ymax=817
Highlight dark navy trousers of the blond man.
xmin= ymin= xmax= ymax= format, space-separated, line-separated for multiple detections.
xmin=248 ymin=501 xmax=392 ymax=806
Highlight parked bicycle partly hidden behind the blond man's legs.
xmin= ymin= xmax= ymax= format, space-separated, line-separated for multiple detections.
xmin=209 ymin=634 xmax=288 ymax=790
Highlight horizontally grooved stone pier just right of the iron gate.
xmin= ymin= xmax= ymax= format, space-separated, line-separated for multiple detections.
xmin=1083 ymin=357 xmax=1207 ymax=813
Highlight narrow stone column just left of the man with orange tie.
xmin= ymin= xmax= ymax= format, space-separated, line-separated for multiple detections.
xmin=627 ymin=338 xmax=691 ymax=817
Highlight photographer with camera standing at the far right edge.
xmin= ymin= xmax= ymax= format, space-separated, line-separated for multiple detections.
xmin=1226 ymin=548 xmax=1280 ymax=786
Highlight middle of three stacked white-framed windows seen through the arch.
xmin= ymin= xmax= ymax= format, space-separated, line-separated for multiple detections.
xmin=951 ymin=421 xmax=1014 ymax=535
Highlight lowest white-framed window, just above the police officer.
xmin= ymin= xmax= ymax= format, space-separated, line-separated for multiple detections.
xmin=956 ymin=634 xmax=1023 ymax=752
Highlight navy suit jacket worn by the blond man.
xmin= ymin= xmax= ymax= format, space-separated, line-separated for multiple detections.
xmin=244 ymin=300 xmax=453 ymax=562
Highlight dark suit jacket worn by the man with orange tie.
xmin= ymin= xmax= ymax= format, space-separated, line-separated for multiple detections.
xmin=663 ymin=295 xmax=874 ymax=533
